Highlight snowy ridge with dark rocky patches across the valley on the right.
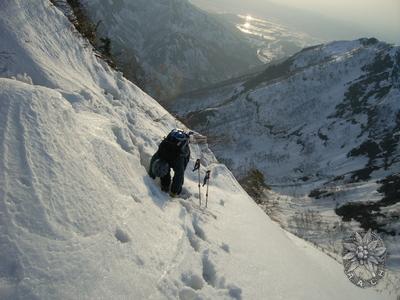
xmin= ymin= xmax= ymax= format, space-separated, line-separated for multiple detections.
xmin=172 ymin=38 xmax=400 ymax=282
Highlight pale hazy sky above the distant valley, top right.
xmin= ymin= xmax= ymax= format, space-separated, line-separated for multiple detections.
xmin=190 ymin=0 xmax=400 ymax=44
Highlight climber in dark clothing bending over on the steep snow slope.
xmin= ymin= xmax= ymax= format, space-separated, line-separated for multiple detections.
xmin=149 ymin=129 xmax=190 ymax=197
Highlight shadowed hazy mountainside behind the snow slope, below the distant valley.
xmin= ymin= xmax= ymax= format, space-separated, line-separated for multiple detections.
xmin=81 ymin=0 xmax=261 ymax=100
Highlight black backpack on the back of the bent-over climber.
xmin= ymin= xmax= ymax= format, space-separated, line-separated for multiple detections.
xmin=158 ymin=129 xmax=189 ymax=162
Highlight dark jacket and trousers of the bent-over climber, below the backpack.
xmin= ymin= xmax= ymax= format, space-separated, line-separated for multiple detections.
xmin=149 ymin=145 xmax=190 ymax=195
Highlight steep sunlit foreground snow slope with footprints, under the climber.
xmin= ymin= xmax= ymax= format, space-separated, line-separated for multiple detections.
xmin=0 ymin=0 xmax=390 ymax=300
